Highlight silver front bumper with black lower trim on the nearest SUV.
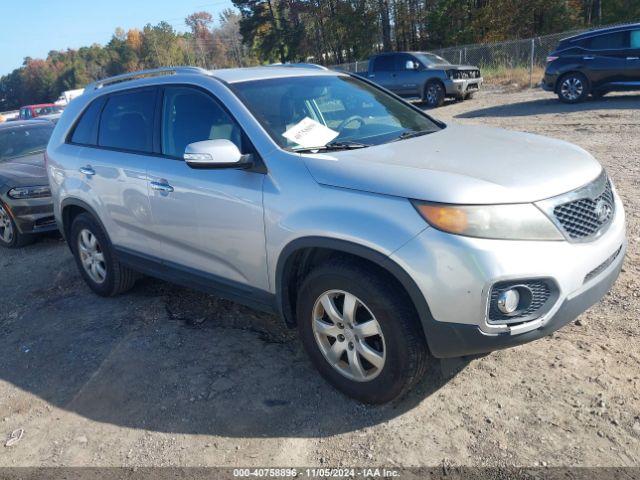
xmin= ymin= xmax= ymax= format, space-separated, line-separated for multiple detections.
xmin=392 ymin=190 xmax=626 ymax=358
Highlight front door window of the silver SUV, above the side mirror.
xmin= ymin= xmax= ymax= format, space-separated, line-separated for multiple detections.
xmin=161 ymin=87 xmax=244 ymax=158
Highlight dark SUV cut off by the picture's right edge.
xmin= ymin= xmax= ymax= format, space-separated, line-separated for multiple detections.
xmin=542 ymin=23 xmax=640 ymax=103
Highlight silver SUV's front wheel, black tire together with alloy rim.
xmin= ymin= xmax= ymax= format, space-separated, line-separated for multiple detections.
xmin=296 ymin=260 xmax=429 ymax=404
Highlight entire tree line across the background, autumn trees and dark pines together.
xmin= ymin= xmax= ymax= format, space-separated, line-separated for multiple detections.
xmin=0 ymin=0 xmax=640 ymax=111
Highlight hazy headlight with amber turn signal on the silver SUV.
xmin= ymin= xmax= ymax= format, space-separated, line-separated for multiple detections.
xmin=414 ymin=202 xmax=564 ymax=240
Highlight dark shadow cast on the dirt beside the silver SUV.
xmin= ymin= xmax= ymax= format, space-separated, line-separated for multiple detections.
xmin=0 ymin=243 xmax=468 ymax=437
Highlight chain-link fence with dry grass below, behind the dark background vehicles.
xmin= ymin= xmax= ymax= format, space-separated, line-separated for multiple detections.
xmin=330 ymin=22 xmax=640 ymax=87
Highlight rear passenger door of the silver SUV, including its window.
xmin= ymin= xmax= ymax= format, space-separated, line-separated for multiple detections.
xmin=71 ymin=87 xmax=160 ymax=256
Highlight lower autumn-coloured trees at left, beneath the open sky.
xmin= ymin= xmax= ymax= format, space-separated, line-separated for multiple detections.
xmin=0 ymin=9 xmax=258 ymax=111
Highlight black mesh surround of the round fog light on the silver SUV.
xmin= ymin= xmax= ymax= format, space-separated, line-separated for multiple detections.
xmin=489 ymin=280 xmax=553 ymax=323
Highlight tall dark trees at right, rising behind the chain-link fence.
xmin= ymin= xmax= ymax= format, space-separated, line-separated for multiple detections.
xmin=233 ymin=0 xmax=640 ymax=64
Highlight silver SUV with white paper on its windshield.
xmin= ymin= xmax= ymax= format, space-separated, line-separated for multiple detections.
xmin=47 ymin=63 xmax=626 ymax=403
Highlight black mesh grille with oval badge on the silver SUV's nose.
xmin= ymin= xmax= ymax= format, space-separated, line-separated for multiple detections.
xmin=553 ymin=179 xmax=615 ymax=240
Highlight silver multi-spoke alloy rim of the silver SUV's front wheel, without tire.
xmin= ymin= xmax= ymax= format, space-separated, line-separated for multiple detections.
xmin=312 ymin=290 xmax=386 ymax=382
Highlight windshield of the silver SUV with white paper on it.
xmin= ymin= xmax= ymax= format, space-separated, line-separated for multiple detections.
xmin=233 ymin=75 xmax=440 ymax=150
